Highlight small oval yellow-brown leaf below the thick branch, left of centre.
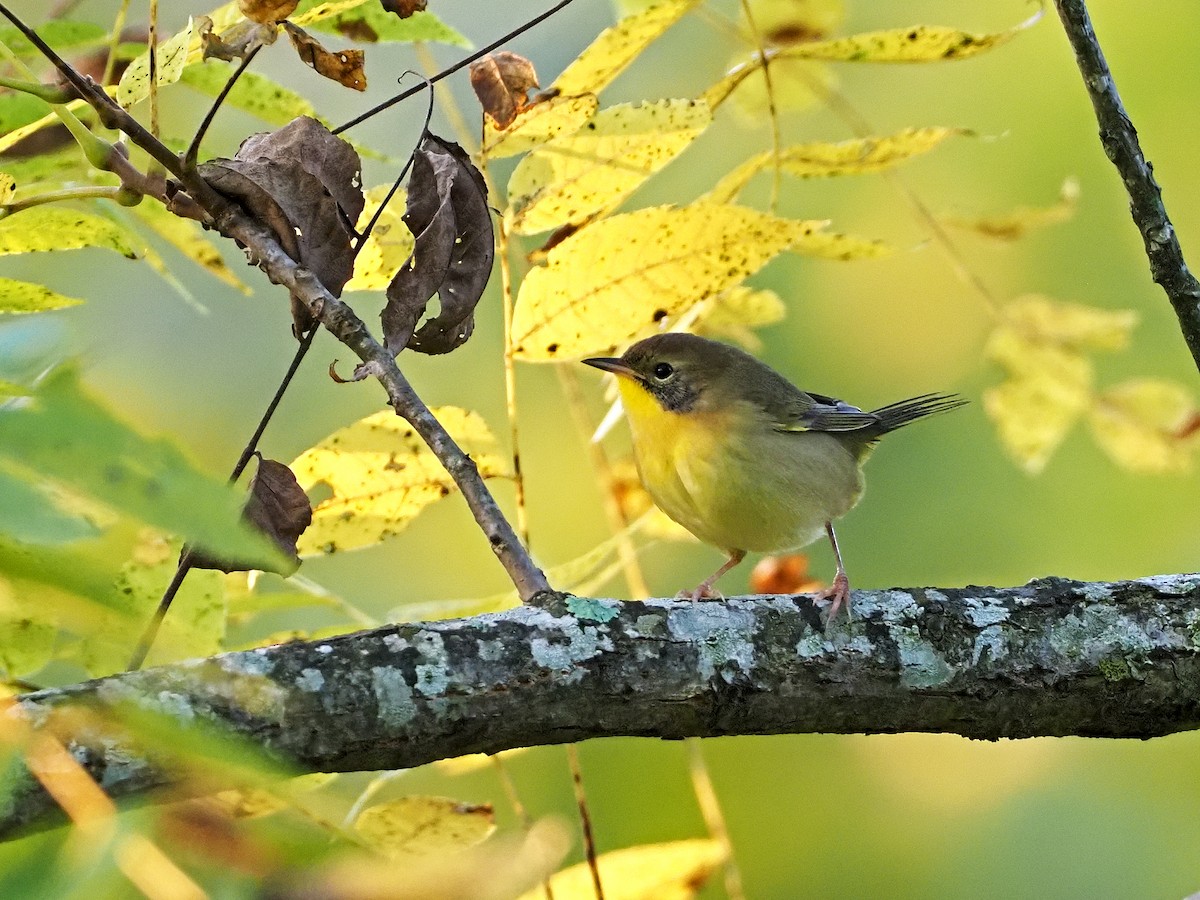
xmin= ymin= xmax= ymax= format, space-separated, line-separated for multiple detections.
xmin=354 ymin=797 xmax=496 ymax=859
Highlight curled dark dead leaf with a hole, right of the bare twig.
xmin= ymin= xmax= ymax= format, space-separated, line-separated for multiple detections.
xmin=382 ymin=134 xmax=494 ymax=354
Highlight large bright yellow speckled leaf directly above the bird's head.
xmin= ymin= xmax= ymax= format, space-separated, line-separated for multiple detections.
xmin=512 ymin=203 xmax=823 ymax=361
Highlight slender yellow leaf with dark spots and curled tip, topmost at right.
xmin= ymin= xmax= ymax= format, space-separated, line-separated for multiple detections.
xmin=779 ymin=10 xmax=1042 ymax=62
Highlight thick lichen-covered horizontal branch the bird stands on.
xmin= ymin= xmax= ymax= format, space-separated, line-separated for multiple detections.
xmin=0 ymin=575 xmax=1200 ymax=836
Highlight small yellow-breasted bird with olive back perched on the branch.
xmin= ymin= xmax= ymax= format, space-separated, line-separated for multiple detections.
xmin=583 ymin=332 xmax=966 ymax=620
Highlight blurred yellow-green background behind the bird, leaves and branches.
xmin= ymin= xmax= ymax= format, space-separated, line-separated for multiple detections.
xmin=0 ymin=0 xmax=1200 ymax=898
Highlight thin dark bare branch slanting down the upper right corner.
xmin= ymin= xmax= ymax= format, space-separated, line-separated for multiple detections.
xmin=1055 ymin=0 xmax=1200 ymax=368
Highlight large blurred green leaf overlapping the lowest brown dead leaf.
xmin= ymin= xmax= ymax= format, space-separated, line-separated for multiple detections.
xmin=0 ymin=370 xmax=285 ymax=565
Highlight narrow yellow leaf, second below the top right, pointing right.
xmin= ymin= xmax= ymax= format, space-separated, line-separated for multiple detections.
xmin=704 ymin=127 xmax=968 ymax=203
